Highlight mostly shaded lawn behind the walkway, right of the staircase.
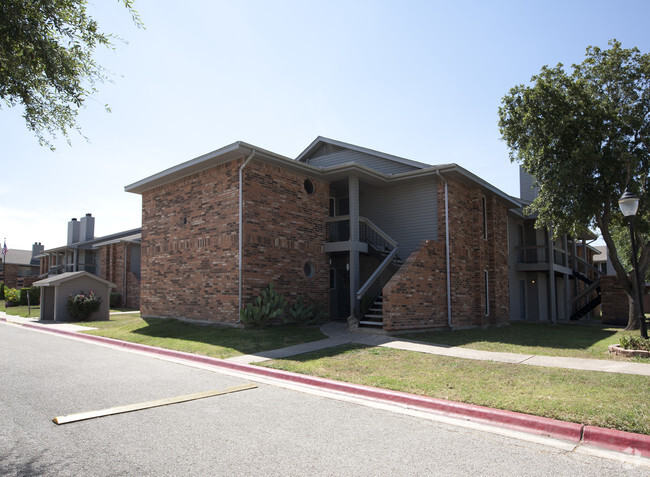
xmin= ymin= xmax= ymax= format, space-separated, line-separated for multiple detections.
xmin=398 ymin=322 xmax=636 ymax=361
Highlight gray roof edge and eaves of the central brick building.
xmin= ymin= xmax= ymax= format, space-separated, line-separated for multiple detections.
xmin=124 ymin=137 xmax=520 ymax=207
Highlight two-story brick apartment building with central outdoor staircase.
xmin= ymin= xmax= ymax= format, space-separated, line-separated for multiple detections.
xmin=125 ymin=137 xmax=520 ymax=331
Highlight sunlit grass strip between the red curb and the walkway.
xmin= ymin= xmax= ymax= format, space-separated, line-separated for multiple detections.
xmin=260 ymin=345 xmax=650 ymax=434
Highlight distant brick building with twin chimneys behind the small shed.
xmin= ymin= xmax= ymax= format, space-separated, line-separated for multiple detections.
xmin=40 ymin=214 xmax=141 ymax=308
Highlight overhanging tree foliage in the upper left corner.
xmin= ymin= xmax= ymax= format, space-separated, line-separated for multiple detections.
xmin=0 ymin=0 xmax=142 ymax=148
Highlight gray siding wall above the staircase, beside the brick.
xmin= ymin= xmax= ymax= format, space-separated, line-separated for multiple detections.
xmin=360 ymin=178 xmax=436 ymax=259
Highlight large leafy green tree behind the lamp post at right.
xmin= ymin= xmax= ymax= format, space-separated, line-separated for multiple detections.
xmin=499 ymin=40 xmax=650 ymax=334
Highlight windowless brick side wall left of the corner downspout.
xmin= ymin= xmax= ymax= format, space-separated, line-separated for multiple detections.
xmin=140 ymin=159 xmax=242 ymax=323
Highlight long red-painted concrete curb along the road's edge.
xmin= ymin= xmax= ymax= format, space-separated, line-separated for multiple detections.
xmin=6 ymin=318 xmax=650 ymax=457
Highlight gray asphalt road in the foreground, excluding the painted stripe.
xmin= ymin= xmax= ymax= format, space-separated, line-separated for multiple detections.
xmin=0 ymin=323 xmax=650 ymax=476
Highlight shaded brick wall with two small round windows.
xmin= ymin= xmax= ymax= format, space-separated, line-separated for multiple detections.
xmin=243 ymin=160 xmax=329 ymax=311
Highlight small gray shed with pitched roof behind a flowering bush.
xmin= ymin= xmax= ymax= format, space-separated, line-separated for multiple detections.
xmin=34 ymin=271 xmax=115 ymax=321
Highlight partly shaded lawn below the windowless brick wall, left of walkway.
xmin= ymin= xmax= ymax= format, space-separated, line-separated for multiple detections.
xmin=78 ymin=313 xmax=326 ymax=358
